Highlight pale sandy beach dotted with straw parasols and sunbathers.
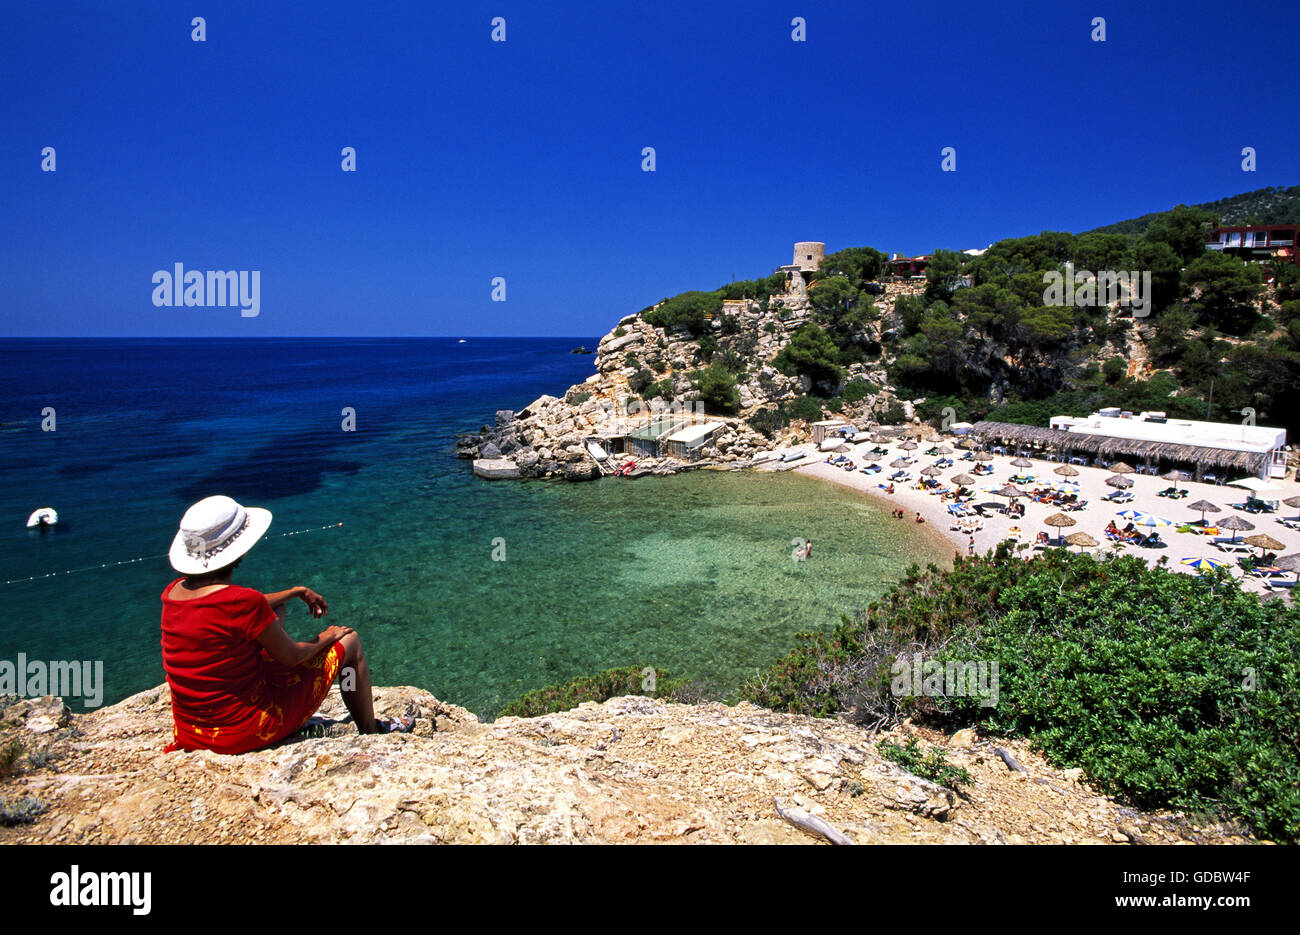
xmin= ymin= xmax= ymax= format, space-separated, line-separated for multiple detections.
xmin=794 ymin=440 xmax=1300 ymax=593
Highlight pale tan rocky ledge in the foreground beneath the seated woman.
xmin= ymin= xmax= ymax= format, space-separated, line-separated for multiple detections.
xmin=0 ymin=687 xmax=1242 ymax=844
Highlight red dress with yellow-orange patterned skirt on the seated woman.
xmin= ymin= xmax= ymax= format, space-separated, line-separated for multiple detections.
xmin=163 ymin=579 xmax=343 ymax=753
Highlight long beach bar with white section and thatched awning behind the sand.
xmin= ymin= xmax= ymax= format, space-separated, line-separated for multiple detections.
xmin=971 ymin=408 xmax=1287 ymax=482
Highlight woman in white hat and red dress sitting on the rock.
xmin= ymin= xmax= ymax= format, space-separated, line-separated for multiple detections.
xmin=161 ymin=497 xmax=415 ymax=753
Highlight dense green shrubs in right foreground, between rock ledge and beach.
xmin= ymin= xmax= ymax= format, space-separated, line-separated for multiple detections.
xmin=744 ymin=547 xmax=1300 ymax=840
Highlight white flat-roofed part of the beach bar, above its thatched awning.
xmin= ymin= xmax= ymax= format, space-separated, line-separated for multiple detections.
xmin=1050 ymin=408 xmax=1287 ymax=479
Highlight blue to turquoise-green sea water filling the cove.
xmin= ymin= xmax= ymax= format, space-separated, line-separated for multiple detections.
xmin=0 ymin=337 xmax=951 ymax=717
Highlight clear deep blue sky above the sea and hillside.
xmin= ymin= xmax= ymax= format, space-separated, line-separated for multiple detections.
xmin=0 ymin=0 xmax=1300 ymax=337
